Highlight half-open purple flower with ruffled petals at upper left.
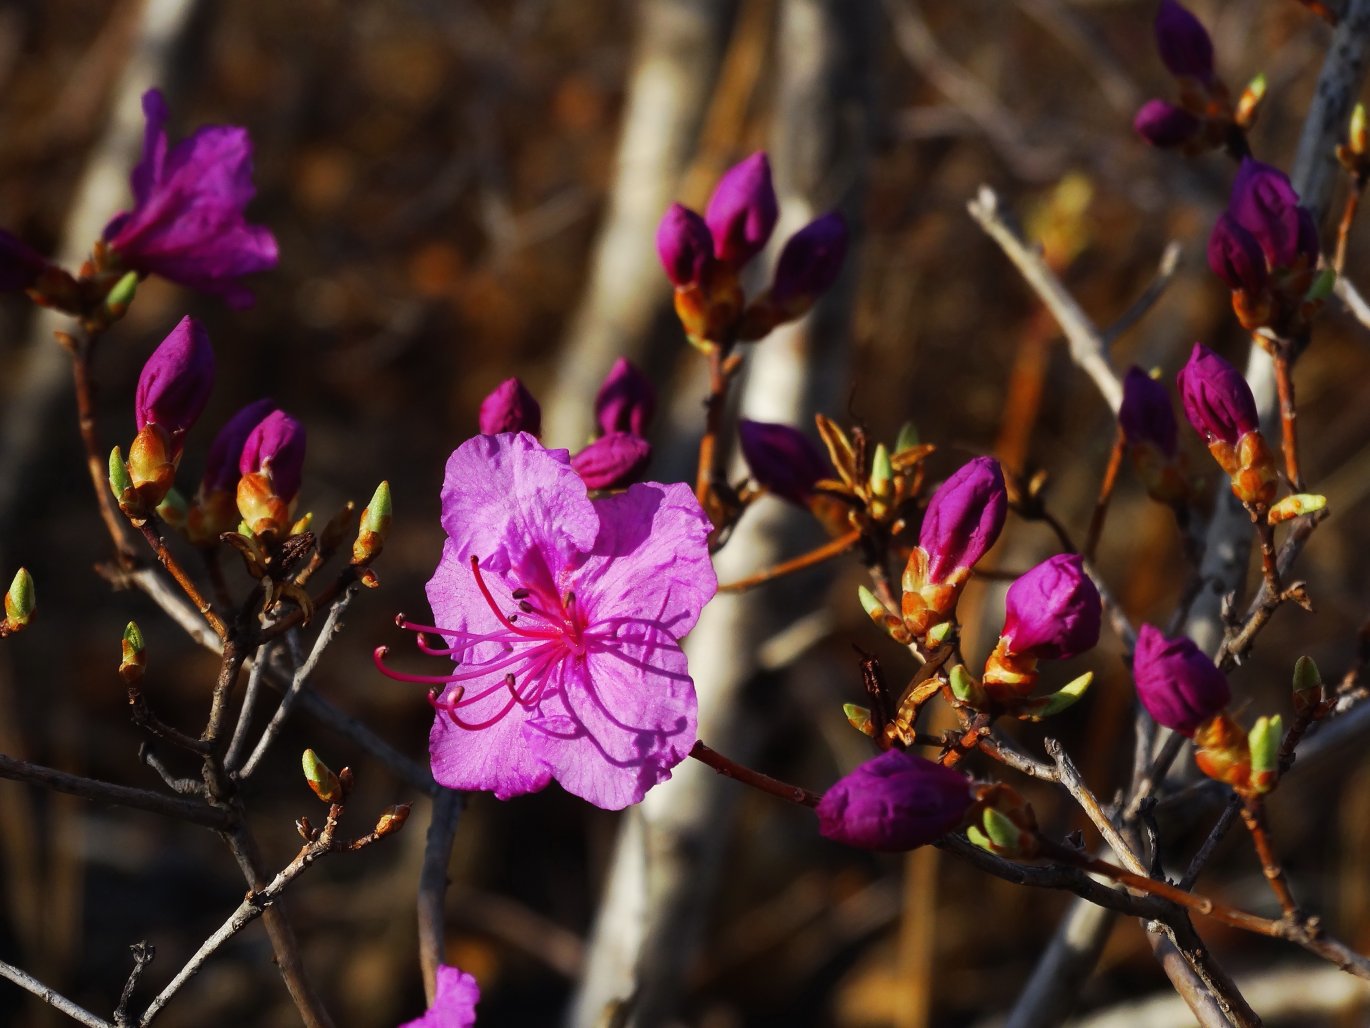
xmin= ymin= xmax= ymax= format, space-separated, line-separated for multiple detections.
xmin=104 ymin=89 xmax=277 ymax=307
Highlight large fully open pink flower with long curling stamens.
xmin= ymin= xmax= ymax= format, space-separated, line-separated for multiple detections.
xmin=377 ymin=433 xmax=718 ymax=810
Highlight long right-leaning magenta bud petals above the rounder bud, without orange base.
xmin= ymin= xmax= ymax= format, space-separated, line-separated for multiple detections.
xmin=918 ymin=456 xmax=1008 ymax=584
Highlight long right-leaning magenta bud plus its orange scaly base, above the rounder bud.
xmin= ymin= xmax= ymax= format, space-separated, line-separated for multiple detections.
xmin=900 ymin=456 xmax=1008 ymax=639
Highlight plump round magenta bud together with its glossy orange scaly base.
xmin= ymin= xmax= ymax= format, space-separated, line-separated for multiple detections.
xmin=982 ymin=554 xmax=1103 ymax=703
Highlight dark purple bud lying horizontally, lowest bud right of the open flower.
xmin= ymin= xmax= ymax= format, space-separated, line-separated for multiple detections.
xmin=815 ymin=750 xmax=973 ymax=853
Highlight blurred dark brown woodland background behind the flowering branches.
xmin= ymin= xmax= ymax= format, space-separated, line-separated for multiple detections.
xmin=0 ymin=0 xmax=1370 ymax=1028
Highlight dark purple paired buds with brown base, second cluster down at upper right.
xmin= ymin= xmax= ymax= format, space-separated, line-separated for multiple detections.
xmin=1208 ymin=158 xmax=1323 ymax=337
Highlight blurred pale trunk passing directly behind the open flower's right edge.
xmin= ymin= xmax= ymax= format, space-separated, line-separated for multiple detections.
xmin=569 ymin=0 xmax=871 ymax=1025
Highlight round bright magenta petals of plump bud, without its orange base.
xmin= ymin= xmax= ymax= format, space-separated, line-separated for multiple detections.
xmin=1001 ymin=554 xmax=1103 ymax=661
